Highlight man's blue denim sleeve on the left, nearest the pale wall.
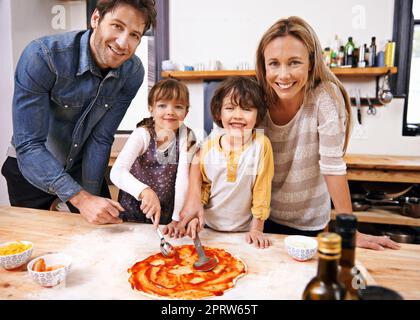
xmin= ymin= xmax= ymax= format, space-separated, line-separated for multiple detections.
xmin=12 ymin=41 xmax=81 ymax=201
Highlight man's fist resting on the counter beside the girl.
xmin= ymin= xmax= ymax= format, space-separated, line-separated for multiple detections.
xmin=69 ymin=190 xmax=124 ymax=224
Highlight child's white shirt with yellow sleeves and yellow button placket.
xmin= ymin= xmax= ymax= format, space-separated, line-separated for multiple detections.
xmin=200 ymin=130 xmax=274 ymax=231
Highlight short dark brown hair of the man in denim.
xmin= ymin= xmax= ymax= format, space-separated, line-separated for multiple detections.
xmin=96 ymin=0 xmax=157 ymax=32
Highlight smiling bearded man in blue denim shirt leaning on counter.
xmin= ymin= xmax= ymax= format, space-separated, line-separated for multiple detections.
xmin=2 ymin=0 xmax=156 ymax=224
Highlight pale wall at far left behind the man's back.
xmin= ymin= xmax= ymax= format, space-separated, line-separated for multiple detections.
xmin=0 ymin=0 xmax=86 ymax=205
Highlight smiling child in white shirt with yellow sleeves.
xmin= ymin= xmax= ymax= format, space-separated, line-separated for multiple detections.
xmin=179 ymin=77 xmax=274 ymax=248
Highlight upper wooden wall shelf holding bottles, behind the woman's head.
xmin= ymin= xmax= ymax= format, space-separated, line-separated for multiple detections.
xmin=162 ymin=67 xmax=397 ymax=80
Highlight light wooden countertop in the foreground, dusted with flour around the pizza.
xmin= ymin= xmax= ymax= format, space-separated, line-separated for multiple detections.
xmin=0 ymin=207 xmax=420 ymax=300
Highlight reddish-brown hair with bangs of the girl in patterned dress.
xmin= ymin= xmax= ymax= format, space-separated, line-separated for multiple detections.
xmin=137 ymin=79 xmax=190 ymax=131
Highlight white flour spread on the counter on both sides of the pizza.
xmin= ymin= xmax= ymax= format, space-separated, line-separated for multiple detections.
xmin=26 ymin=224 xmax=317 ymax=300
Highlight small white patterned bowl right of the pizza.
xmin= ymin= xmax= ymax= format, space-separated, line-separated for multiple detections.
xmin=284 ymin=236 xmax=318 ymax=261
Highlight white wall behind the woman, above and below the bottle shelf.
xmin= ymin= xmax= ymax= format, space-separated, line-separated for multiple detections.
xmin=169 ymin=0 xmax=420 ymax=156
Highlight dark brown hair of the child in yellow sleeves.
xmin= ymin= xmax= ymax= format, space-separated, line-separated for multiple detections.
xmin=210 ymin=76 xmax=267 ymax=127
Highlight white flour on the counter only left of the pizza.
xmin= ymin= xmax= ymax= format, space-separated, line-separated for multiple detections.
xmin=27 ymin=225 xmax=191 ymax=300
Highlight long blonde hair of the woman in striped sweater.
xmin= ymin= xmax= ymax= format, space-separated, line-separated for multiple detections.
xmin=255 ymin=17 xmax=351 ymax=151
